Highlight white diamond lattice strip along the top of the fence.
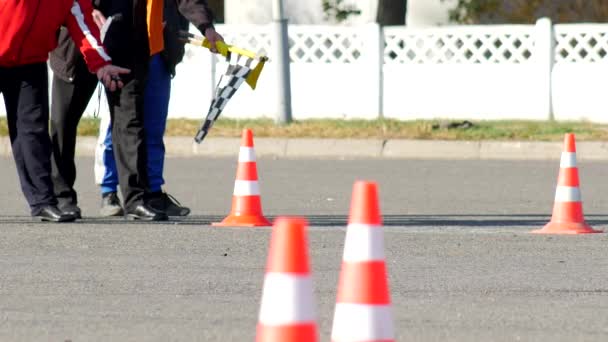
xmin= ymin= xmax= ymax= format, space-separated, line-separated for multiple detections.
xmin=210 ymin=24 xmax=608 ymax=64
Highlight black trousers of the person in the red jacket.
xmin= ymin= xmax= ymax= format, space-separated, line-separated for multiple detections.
xmin=0 ymin=63 xmax=57 ymax=215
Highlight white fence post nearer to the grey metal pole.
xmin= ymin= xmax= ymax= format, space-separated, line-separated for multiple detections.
xmin=362 ymin=23 xmax=384 ymax=119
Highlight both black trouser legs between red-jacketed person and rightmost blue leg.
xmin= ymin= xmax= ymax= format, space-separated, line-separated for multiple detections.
xmin=51 ymin=58 xmax=148 ymax=210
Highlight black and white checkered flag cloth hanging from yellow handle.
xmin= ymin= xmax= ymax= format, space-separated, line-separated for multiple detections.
xmin=194 ymin=52 xmax=259 ymax=144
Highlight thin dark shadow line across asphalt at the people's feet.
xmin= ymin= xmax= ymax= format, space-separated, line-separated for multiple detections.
xmin=0 ymin=214 xmax=608 ymax=228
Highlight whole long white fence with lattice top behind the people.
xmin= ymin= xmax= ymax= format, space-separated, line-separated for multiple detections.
xmin=0 ymin=21 xmax=608 ymax=122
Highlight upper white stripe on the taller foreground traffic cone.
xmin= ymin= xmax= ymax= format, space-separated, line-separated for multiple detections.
xmin=343 ymin=223 xmax=384 ymax=262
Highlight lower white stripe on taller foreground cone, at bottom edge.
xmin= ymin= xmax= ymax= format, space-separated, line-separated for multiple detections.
xmin=331 ymin=303 xmax=395 ymax=342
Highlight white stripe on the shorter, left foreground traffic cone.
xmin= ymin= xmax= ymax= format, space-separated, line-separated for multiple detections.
xmin=259 ymin=272 xmax=315 ymax=326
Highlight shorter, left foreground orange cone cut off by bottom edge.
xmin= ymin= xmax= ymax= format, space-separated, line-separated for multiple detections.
xmin=256 ymin=217 xmax=317 ymax=342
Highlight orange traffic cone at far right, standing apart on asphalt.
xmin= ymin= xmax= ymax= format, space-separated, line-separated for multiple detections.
xmin=532 ymin=133 xmax=602 ymax=234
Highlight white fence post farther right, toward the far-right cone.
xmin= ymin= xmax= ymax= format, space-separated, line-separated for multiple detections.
xmin=534 ymin=18 xmax=555 ymax=120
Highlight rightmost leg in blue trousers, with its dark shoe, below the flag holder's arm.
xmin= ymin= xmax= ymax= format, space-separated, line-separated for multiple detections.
xmin=144 ymin=54 xmax=190 ymax=216
